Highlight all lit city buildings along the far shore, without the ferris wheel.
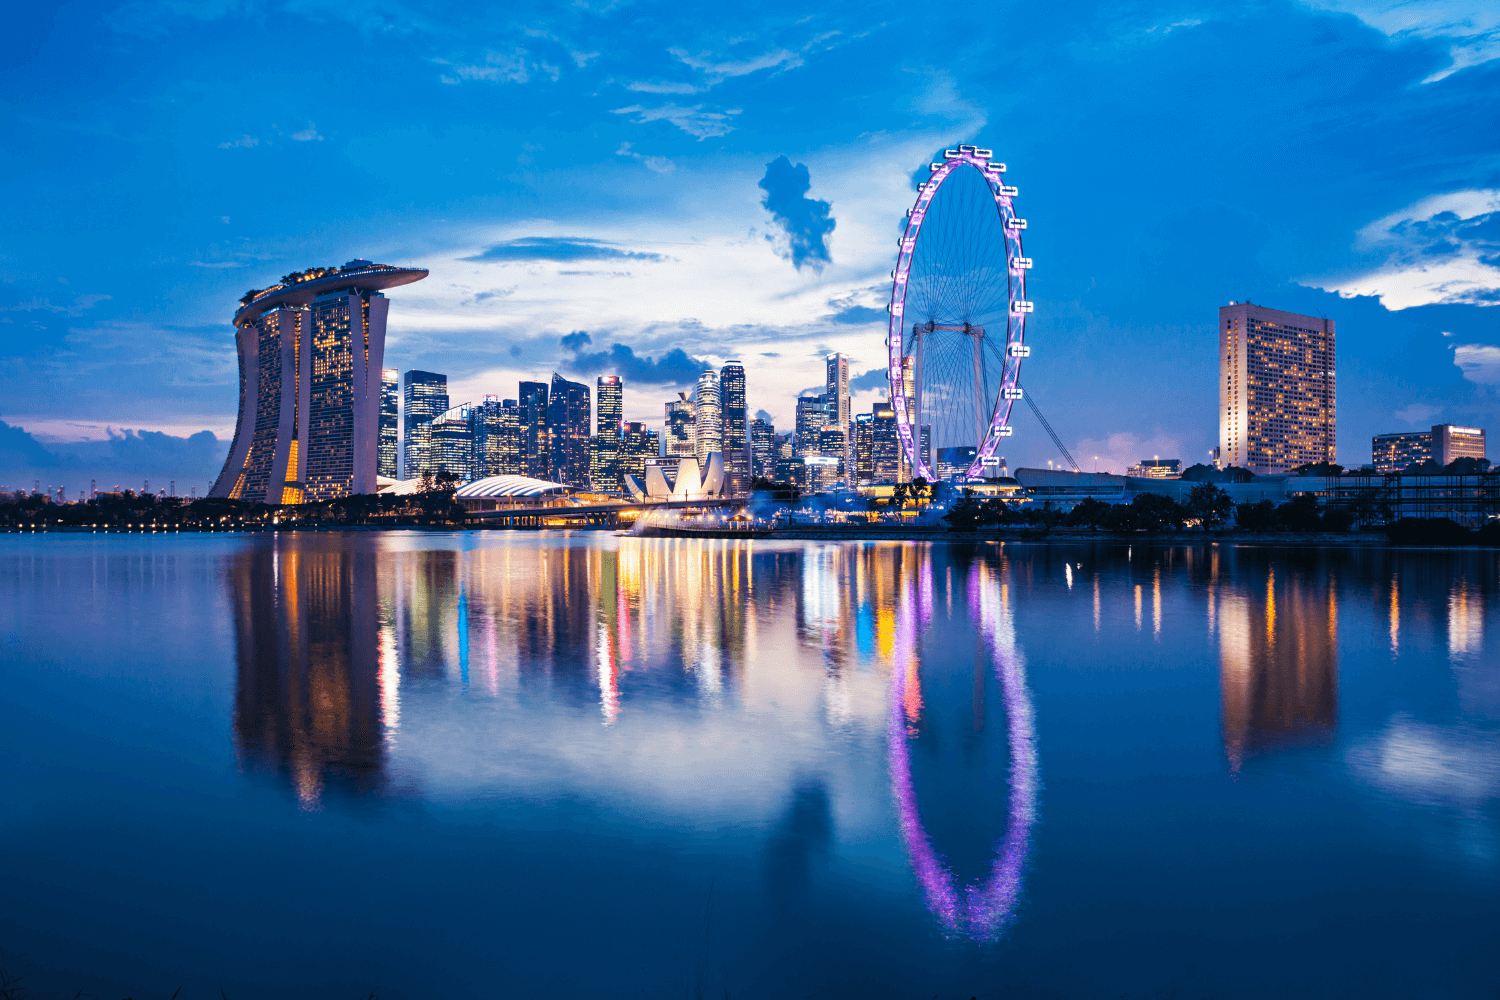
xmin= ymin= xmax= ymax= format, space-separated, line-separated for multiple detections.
xmin=210 ymin=259 xmax=1485 ymax=502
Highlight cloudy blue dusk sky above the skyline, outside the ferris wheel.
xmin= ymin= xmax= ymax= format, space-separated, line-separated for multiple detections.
xmin=0 ymin=0 xmax=1500 ymax=481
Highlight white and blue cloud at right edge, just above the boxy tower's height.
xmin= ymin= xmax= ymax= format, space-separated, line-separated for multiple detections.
xmin=1302 ymin=189 xmax=1500 ymax=310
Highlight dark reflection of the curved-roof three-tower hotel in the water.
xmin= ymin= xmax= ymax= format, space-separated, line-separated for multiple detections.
xmin=230 ymin=544 xmax=390 ymax=808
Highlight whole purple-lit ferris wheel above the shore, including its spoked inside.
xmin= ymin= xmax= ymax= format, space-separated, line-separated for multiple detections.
xmin=887 ymin=145 xmax=1032 ymax=480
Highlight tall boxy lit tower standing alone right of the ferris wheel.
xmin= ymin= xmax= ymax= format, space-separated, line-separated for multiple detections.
xmin=1220 ymin=301 xmax=1337 ymax=475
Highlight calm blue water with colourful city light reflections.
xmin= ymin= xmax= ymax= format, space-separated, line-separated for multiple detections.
xmin=0 ymin=532 xmax=1500 ymax=1000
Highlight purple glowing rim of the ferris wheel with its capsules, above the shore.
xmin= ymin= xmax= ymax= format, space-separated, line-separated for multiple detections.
xmin=885 ymin=145 xmax=1032 ymax=480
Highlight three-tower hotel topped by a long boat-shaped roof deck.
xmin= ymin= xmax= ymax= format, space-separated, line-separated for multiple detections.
xmin=210 ymin=261 xmax=428 ymax=504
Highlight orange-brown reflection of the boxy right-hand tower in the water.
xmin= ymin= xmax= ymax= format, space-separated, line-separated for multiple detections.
xmin=1209 ymin=565 xmax=1338 ymax=772
